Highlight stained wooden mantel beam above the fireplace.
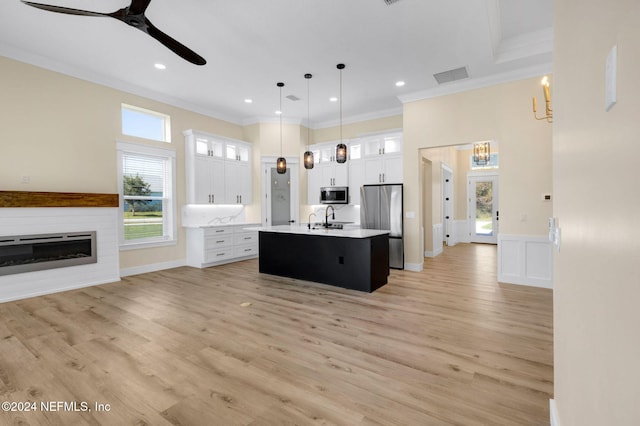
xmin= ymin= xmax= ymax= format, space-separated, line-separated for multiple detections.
xmin=0 ymin=191 xmax=119 ymax=208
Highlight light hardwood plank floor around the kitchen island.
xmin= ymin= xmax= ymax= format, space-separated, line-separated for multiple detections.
xmin=0 ymin=244 xmax=553 ymax=426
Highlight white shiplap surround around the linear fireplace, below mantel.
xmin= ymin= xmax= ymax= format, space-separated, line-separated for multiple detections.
xmin=0 ymin=207 xmax=120 ymax=302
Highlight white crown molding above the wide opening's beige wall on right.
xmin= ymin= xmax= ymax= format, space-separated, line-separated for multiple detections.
xmin=398 ymin=63 xmax=553 ymax=104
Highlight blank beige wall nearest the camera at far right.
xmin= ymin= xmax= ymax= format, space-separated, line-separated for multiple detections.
xmin=552 ymin=0 xmax=640 ymax=426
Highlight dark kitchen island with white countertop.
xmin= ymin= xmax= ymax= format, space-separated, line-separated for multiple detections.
xmin=253 ymin=225 xmax=389 ymax=292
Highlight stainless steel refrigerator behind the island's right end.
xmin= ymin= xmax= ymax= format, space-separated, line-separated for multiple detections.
xmin=360 ymin=184 xmax=404 ymax=269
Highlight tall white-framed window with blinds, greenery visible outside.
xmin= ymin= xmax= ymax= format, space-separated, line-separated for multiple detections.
xmin=118 ymin=142 xmax=176 ymax=248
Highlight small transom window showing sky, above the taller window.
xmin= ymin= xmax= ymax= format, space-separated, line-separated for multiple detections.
xmin=121 ymin=104 xmax=171 ymax=142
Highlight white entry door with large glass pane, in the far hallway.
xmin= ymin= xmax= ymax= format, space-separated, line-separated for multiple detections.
xmin=468 ymin=175 xmax=499 ymax=244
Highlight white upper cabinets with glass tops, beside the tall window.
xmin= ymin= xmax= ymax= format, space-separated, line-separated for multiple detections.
xmin=184 ymin=130 xmax=252 ymax=204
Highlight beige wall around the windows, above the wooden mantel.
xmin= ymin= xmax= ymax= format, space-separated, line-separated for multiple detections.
xmin=0 ymin=57 xmax=245 ymax=268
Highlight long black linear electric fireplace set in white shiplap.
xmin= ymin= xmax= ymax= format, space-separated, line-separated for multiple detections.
xmin=0 ymin=231 xmax=98 ymax=275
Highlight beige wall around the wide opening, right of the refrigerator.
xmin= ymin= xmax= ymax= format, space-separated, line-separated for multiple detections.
xmin=403 ymin=78 xmax=552 ymax=264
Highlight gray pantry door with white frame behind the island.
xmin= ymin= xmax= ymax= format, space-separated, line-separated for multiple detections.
xmin=262 ymin=158 xmax=300 ymax=226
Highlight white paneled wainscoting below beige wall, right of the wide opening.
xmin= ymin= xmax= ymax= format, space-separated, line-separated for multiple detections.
xmin=498 ymin=234 xmax=553 ymax=288
